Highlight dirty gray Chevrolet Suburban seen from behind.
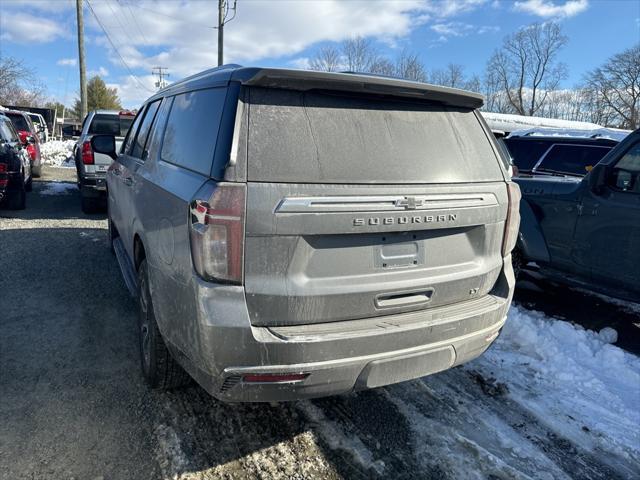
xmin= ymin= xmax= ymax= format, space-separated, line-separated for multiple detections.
xmin=91 ymin=65 xmax=520 ymax=401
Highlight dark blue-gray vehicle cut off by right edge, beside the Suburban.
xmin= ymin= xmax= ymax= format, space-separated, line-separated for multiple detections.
xmin=513 ymin=130 xmax=640 ymax=301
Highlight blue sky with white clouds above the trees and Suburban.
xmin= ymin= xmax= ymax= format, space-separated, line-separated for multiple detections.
xmin=0 ymin=0 xmax=640 ymax=107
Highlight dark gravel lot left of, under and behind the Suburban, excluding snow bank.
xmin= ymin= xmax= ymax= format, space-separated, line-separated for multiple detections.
xmin=0 ymin=168 xmax=637 ymax=480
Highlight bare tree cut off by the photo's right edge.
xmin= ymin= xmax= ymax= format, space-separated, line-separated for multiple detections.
xmin=586 ymin=44 xmax=640 ymax=129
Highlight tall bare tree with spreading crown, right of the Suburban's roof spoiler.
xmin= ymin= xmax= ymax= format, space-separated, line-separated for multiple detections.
xmin=487 ymin=22 xmax=567 ymax=115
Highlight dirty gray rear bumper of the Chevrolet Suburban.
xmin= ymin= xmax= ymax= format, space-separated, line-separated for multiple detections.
xmin=172 ymin=257 xmax=515 ymax=402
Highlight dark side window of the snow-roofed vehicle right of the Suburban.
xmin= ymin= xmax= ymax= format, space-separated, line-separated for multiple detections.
xmin=536 ymin=145 xmax=611 ymax=175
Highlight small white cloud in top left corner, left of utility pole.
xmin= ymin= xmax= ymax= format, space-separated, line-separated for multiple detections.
xmin=0 ymin=11 xmax=67 ymax=43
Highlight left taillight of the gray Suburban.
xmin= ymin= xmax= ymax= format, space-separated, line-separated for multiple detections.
xmin=189 ymin=183 xmax=246 ymax=284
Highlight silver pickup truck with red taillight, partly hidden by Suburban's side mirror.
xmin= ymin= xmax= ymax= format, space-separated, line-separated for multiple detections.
xmin=73 ymin=110 xmax=135 ymax=213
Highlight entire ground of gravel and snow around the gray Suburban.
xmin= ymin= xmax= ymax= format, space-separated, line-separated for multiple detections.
xmin=0 ymin=170 xmax=640 ymax=480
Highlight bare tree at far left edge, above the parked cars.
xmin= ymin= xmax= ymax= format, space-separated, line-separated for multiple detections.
xmin=0 ymin=57 xmax=44 ymax=107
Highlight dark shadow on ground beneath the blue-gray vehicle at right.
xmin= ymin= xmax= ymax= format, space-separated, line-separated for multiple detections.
xmin=514 ymin=271 xmax=640 ymax=355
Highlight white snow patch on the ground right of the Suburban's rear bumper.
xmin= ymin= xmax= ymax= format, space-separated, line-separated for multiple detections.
xmin=472 ymin=306 xmax=640 ymax=464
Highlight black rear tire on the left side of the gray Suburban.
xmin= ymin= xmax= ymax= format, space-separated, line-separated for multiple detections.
xmin=138 ymin=260 xmax=191 ymax=390
